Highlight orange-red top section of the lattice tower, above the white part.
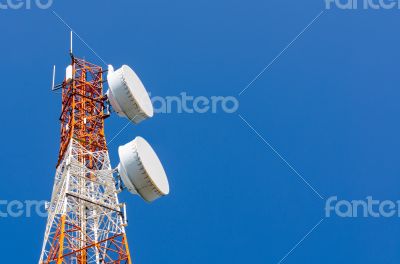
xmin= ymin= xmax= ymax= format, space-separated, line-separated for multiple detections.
xmin=58 ymin=56 xmax=109 ymax=167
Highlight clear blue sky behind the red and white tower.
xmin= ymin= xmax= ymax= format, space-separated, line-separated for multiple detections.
xmin=0 ymin=0 xmax=400 ymax=264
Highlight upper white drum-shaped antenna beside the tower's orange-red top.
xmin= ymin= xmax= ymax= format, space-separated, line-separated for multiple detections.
xmin=107 ymin=65 xmax=154 ymax=124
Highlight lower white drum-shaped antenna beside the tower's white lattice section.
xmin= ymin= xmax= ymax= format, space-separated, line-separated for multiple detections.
xmin=118 ymin=137 xmax=169 ymax=202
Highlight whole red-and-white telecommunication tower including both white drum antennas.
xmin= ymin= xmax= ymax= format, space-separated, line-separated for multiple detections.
xmin=39 ymin=33 xmax=169 ymax=264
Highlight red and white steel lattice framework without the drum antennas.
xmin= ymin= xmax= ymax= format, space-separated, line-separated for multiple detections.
xmin=39 ymin=57 xmax=131 ymax=264
